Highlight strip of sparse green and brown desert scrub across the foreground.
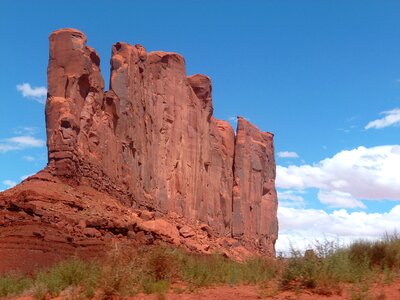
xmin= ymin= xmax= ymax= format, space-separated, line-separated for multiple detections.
xmin=0 ymin=235 xmax=400 ymax=299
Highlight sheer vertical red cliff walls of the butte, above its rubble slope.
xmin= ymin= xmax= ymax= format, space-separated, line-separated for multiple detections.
xmin=0 ymin=29 xmax=278 ymax=274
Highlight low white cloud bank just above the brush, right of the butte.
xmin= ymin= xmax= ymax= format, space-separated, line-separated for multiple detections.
xmin=276 ymin=205 xmax=400 ymax=252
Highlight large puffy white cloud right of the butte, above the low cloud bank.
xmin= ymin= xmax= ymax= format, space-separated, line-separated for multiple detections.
xmin=276 ymin=145 xmax=400 ymax=200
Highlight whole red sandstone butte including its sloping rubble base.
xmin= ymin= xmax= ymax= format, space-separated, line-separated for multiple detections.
xmin=0 ymin=29 xmax=278 ymax=272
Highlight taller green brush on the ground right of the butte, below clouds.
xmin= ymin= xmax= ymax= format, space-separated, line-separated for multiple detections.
xmin=279 ymin=235 xmax=400 ymax=298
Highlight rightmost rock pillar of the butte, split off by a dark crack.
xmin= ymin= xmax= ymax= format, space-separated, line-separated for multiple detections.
xmin=232 ymin=117 xmax=278 ymax=251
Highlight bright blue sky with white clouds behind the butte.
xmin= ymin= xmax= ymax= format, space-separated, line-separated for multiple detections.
xmin=0 ymin=0 xmax=400 ymax=250
